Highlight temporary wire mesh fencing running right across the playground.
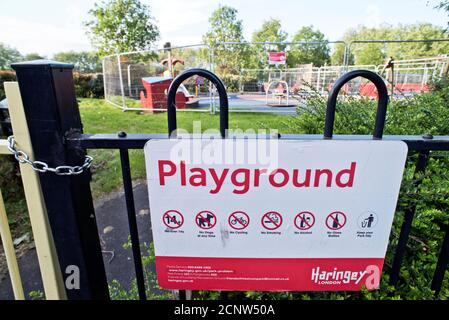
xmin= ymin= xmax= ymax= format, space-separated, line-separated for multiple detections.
xmin=103 ymin=39 xmax=449 ymax=114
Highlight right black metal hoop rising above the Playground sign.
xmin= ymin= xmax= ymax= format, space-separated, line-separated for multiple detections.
xmin=324 ymin=70 xmax=388 ymax=139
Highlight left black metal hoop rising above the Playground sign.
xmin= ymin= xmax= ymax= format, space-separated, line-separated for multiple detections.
xmin=167 ymin=69 xmax=229 ymax=138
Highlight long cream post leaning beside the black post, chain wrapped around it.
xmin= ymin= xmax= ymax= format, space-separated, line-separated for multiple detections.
xmin=4 ymin=82 xmax=67 ymax=300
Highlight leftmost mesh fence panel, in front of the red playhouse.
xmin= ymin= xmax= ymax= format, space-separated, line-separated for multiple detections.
xmin=103 ymin=45 xmax=212 ymax=111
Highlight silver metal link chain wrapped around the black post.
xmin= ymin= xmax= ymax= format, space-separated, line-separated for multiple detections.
xmin=7 ymin=136 xmax=93 ymax=176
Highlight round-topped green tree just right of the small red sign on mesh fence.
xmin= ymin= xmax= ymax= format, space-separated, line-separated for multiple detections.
xmin=287 ymin=26 xmax=330 ymax=67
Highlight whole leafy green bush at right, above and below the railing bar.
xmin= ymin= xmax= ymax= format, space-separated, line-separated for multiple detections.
xmin=193 ymin=85 xmax=449 ymax=300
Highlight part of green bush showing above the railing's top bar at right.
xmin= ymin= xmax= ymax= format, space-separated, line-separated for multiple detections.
xmin=290 ymin=90 xmax=449 ymax=135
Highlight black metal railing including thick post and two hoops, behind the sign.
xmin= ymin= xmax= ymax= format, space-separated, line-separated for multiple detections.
xmin=5 ymin=63 xmax=449 ymax=299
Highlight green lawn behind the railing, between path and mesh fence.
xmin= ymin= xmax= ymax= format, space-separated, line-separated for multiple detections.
xmin=79 ymin=99 xmax=298 ymax=198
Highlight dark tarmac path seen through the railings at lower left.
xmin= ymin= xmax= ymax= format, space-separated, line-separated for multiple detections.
xmin=0 ymin=183 xmax=152 ymax=300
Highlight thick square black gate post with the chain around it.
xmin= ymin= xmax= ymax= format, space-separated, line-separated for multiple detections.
xmin=12 ymin=60 xmax=109 ymax=300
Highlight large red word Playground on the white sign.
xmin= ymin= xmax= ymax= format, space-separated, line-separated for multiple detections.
xmin=158 ymin=160 xmax=356 ymax=194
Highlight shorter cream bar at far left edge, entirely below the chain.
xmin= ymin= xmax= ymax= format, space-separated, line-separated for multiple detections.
xmin=0 ymin=191 xmax=25 ymax=300
